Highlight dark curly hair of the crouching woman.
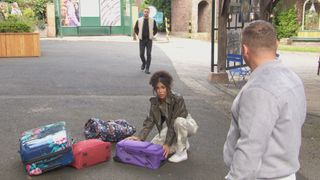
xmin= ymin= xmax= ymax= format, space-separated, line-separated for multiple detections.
xmin=149 ymin=71 xmax=173 ymax=92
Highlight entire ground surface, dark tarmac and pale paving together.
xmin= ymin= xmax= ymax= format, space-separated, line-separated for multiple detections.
xmin=0 ymin=36 xmax=320 ymax=179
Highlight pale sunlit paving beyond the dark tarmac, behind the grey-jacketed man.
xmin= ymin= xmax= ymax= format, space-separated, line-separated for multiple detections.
xmin=158 ymin=38 xmax=320 ymax=180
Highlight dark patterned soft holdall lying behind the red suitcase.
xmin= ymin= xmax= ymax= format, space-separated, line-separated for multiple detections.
xmin=84 ymin=118 xmax=136 ymax=142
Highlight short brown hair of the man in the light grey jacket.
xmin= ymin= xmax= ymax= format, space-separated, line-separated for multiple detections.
xmin=242 ymin=20 xmax=277 ymax=53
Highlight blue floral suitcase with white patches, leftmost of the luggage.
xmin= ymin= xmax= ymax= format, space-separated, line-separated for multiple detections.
xmin=20 ymin=121 xmax=73 ymax=175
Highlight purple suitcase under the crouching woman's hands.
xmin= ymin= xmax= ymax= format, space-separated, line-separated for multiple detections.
xmin=114 ymin=139 xmax=165 ymax=169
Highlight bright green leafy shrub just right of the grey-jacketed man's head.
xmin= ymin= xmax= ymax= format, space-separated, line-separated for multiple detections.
xmin=273 ymin=8 xmax=299 ymax=39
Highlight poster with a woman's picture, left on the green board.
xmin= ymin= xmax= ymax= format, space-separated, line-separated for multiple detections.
xmin=60 ymin=0 xmax=80 ymax=27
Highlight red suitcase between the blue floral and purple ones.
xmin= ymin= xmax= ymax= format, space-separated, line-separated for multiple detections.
xmin=71 ymin=139 xmax=111 ymax=169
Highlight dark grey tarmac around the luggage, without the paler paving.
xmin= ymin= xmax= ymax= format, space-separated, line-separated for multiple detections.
xmin=0 ymin=41 xmax=228 ymax=179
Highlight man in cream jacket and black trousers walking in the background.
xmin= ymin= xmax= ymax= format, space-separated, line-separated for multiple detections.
xmin=134 ymin=8 xmax=158 ymax=74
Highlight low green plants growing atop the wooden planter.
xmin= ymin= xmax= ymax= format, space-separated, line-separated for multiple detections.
xmin=0 ymin=15 xmax=34 ymax=33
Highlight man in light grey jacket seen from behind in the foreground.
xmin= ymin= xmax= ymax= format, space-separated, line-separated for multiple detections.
xmin=223 ymin=20 xmax=306 ymax=180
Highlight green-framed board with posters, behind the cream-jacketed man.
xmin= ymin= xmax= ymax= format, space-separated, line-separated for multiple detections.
xmin=54 ymin=0 xmax=132 ymax=36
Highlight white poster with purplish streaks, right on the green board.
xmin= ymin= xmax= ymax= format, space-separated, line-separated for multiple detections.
xmin=100 ymin=0 xmax=121 ymax=26
